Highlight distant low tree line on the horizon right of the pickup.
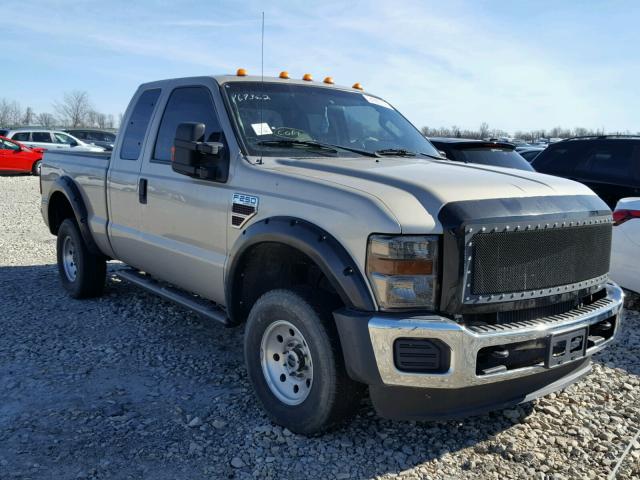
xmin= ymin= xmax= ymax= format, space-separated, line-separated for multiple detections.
xmin=421 ymin=122 xmax=640 ymax=142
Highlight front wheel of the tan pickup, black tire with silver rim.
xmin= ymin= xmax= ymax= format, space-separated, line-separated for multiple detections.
xmin=244 ymin=290 xmax=364 ymax=435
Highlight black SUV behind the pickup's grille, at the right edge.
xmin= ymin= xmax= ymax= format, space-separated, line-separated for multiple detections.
xmin=533 ymin=135 xmax=640 ymax=209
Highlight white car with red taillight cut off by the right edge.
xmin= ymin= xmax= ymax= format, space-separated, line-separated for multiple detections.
xmin=610 ymin=197 xmax=640 ymax=293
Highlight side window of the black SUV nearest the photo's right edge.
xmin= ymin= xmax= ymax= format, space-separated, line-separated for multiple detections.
xmin=581 ymin=140 xmax=636 ymax=184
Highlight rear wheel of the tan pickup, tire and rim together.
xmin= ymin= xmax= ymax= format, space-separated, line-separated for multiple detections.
xmin=56 ymin=218 xmax=107 ymax=298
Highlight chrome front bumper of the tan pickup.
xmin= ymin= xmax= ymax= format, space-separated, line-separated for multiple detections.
xmin=335 ymin=283 xmax=624 ymax=418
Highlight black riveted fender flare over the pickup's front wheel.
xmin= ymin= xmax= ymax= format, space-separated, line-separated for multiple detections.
xmin=225 ymin=217 xmax=376 ymax=319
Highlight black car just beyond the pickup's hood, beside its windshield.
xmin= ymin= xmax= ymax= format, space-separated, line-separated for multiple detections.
xmin=429 ymin=137 xmax=533 ymax=171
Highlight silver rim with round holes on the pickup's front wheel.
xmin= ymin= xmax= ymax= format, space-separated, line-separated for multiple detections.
xmin=260 ymin=320 xmax=313 ymax=405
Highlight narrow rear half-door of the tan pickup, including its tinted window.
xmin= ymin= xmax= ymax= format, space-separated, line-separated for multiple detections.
xmin=107 ymin=88 xmax=161 ymax=267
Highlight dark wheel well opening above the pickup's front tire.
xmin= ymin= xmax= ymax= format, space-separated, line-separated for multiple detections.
xmin=230 ymin=242 xmax=344 ymax=324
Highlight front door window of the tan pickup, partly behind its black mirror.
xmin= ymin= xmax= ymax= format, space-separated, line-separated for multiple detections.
xmin=153 ymin=87 xmax=221 ymax=162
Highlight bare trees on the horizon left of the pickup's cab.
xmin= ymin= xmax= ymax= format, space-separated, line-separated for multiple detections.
xmin=0 ymin=90 xmax=122 ymax=129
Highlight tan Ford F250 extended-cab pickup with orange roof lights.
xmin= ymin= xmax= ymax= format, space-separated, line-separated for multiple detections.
xmin=41 ymin=70 xmax=623 ymax=434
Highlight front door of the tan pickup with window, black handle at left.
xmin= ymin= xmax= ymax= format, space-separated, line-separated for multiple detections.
xmin=139 ymin=85 xmax=231 ymax=303
